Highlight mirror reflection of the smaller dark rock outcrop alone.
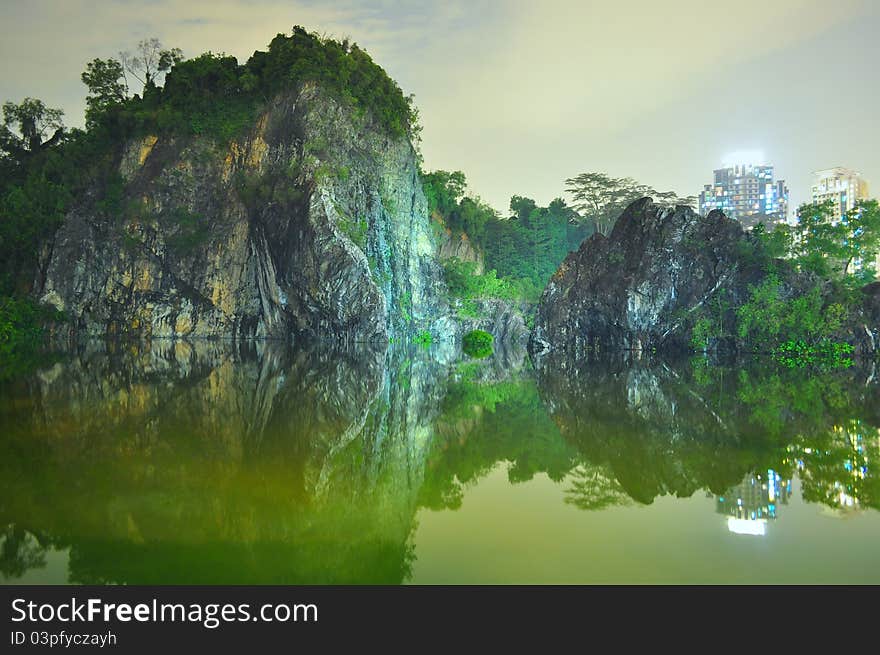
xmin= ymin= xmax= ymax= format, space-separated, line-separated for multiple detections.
xmin=539 ymin=359 xmax=754 ymax=503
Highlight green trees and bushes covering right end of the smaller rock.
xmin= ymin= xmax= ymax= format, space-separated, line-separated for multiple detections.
xmin=691 ymin=201 xmax=880 ymax=367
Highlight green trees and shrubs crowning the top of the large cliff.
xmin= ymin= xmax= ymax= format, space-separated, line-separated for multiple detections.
xmin=75 ymin=26 xmax=419 ymax=149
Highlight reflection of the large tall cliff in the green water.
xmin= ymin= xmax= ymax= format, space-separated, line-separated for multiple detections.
xmin=0 ymin=343 xmax=438 ymax=583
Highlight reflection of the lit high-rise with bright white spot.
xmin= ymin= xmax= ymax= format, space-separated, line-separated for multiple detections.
xmin=715 ymin=469 xmax=791 ymax=535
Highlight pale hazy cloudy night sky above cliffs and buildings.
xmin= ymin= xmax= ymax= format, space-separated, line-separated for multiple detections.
xmin=0 ymin=0 xmax=880 ymax=211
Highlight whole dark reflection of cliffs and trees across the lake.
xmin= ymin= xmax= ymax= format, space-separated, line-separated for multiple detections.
xmin=0 ymin=342 xmax=880 ymax=583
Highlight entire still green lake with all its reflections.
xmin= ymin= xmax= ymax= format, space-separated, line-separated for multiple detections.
xmin=0 ymin=343 xmax=880 ymax=584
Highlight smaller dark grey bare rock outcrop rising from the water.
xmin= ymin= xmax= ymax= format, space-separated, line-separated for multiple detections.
xmin=531 ymin=198 xmax=745 ymax=353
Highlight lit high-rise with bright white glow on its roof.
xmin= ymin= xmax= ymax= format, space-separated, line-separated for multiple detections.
xmin=700 ymin=164 xmax=788 ymax=227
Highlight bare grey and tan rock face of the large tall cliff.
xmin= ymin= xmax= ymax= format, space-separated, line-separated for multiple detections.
xmin=37 ymin=84 xmax=455 ymax=341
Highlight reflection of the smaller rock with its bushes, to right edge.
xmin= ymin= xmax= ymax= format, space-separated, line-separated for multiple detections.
xmin=537 ymin=354 xmax=877 ymax=506
